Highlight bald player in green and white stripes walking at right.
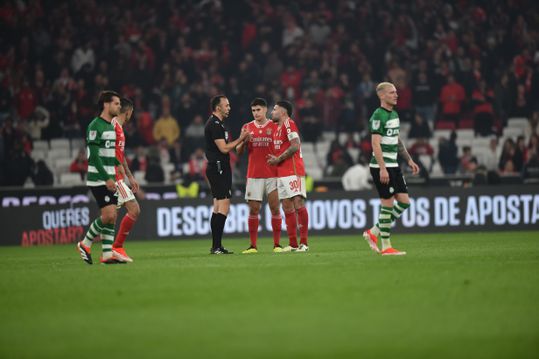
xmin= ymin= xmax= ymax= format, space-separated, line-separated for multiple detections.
xmin=363 ymin=82 xmax=419 ymax=255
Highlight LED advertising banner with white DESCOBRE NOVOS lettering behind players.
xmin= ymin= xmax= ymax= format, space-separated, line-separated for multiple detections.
xmin=0 ymin=185 xmax=539 ymax=246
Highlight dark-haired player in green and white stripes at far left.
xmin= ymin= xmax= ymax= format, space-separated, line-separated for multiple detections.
xmin=77 ymin=91 xmax=125 ymax=264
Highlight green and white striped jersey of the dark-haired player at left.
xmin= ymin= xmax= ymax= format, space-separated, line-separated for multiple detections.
xmin=86 ymin=117 xmax=118 ymax=187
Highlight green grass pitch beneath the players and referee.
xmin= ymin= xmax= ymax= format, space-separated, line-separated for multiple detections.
xmin=0 ymin=232 xmax=539 ymax=358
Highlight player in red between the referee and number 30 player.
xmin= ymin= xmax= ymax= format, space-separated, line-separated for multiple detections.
xmin=236 ymin=98 xmax=283 ymax=254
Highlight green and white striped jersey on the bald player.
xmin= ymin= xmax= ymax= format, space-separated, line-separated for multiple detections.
xmin=369 ymin=107 xmax=400 ymax=168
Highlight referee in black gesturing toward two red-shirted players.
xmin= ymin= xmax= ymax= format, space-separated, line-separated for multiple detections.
xmin=204 ymin=95 xmax=249 ymax=254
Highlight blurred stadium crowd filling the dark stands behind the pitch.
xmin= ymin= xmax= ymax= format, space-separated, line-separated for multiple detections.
xmin=0 ymin=0 xmax=539 ymax=186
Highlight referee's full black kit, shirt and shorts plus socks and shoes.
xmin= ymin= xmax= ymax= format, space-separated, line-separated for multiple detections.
xmin=204 ymin=115 xmax=232 ymax=254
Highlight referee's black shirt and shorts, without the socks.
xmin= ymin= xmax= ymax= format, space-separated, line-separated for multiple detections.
xmin=204 ymin=115 xmax=232 ymax=199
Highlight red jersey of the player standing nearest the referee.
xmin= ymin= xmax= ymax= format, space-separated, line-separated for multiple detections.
xmin=243 ymin=120 xmax=277 ymax=178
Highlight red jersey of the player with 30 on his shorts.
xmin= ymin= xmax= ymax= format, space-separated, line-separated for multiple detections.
xmin=273 ymin=118 xmax=305 ymax=177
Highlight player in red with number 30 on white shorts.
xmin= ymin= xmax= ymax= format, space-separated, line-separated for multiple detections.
xmin=267 ymin=101 xmax=309 ymax=252
